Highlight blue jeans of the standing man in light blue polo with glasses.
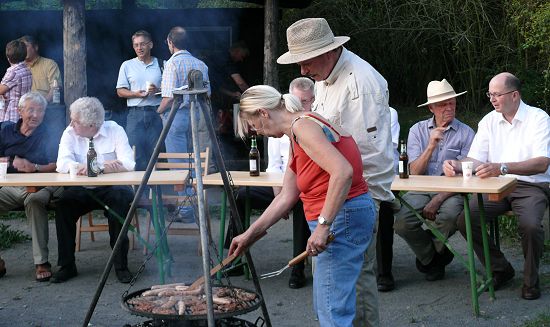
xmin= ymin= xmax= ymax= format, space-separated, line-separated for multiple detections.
xmin=126 ymin=106 xmax=162 ymax=170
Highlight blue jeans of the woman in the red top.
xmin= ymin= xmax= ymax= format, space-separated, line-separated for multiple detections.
xmin=308 ymin=193 xmax=376 ymax=327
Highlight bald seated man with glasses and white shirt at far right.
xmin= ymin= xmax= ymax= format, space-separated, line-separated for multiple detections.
xmin=443 ymin=73 xmax=550 ymax=300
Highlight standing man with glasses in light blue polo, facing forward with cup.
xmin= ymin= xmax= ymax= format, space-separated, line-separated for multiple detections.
xmin=116 ymin=30 xmax=162 ymax=170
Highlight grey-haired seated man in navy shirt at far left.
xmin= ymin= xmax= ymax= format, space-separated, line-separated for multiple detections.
xmin=0 ymin=92 xmax=61 ymax=282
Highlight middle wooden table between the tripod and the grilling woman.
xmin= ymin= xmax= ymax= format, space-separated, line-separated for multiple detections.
xmin=202 ymin=171 xmax=284 ymax=279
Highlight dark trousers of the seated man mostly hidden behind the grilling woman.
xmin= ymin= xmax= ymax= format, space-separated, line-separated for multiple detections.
xmin=225 ymin=186 xmax=311 ymax=268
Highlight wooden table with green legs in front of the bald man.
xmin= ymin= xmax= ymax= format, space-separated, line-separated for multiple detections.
xmin=391 ymin=175 xmax=516 ymax=316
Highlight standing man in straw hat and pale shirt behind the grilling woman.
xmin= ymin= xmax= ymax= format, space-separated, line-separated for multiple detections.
xmin=277 ymin=18 xmax=394 ymax=327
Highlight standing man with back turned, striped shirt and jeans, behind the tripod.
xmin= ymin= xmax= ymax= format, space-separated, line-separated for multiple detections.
xmin=157 ymin=26 xmax=210 ymax=223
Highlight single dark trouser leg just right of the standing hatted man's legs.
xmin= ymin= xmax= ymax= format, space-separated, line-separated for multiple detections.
xmin=376 ymin=200 xmax=397 ymax=276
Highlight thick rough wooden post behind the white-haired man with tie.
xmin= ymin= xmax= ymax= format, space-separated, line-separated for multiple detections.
xmin=63 ymin=0 xmax=88 ymax=113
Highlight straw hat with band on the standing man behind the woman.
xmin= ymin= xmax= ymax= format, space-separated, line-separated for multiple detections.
xmin=277 ymin=18 xmax=349 ymax=64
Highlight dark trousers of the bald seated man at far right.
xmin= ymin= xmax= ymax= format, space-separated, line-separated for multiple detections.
xmin=457 ymin=181 xmax=550 ymax=287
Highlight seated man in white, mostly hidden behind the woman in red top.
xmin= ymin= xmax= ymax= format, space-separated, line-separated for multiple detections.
xmin=225 ymin=77 xmax=315 ymax=289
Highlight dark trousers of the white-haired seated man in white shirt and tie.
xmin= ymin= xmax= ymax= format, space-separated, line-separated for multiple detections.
xmin=55 ymin=186 xmax=134 ymax=269
